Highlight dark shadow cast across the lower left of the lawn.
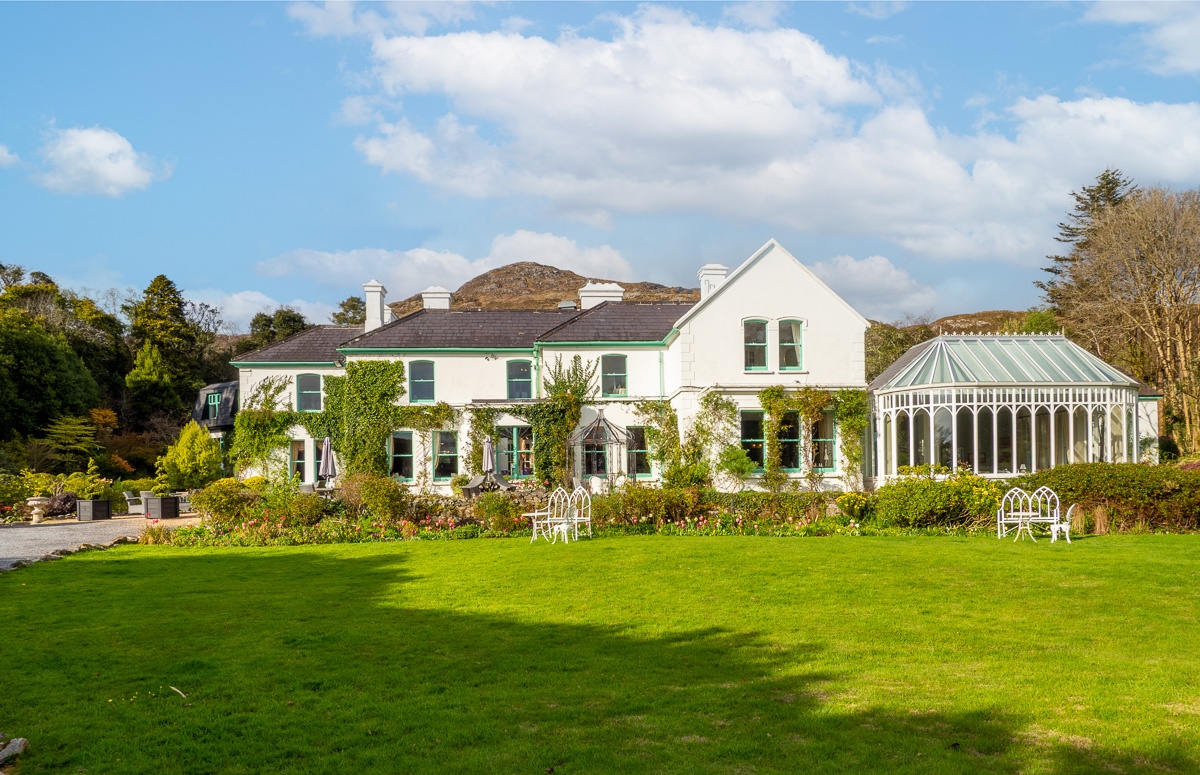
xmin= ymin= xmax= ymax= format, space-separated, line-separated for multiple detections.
xmin=0 ymin=552 xmax=1195 ymax=775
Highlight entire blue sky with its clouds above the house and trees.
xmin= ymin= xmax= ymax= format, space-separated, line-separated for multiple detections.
xmin=0 ymin=2 xmax=1200 ymax=328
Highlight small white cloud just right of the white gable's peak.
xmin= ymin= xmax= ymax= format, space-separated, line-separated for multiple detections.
xmin=811 ymin=256 xmax=937 ymax=320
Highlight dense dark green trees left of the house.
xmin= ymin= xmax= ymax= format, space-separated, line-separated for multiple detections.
xmin=0 ymin=264 xmax=364 ymax=476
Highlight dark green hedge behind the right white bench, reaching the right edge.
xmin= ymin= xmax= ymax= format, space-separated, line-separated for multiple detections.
xmin=1008 ymin=463 xmax=1200 ymax=533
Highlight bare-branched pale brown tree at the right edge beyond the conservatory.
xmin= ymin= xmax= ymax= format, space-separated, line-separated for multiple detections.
xmin=1058 ymin=187 xmax=1200 ymax=452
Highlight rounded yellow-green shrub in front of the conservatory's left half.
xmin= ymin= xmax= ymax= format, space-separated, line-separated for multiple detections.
xmin=875 ymin=473 xmax=1003 ymax=528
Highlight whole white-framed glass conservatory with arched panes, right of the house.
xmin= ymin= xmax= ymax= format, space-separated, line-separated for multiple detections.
xmin=868 ymin=335 xmax=1142 ymax=479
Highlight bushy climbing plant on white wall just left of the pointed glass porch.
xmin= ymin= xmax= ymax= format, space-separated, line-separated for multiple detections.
xmin=508 ymin=355 xmax=600 ymax=483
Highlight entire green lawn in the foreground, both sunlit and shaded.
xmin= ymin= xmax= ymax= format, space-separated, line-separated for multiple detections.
xmin=0 ymin=535 xmax=1200 ymax=775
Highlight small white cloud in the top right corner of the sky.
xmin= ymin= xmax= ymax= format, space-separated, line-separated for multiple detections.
xmin=1085 ymin=2 xmax=1200 ymax=76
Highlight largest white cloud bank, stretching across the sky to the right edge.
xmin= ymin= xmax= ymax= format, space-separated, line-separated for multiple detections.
xmin=309 ymin=5 xmax=1200 ymax=265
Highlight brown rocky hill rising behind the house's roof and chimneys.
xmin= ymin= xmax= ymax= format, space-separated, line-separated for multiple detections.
xmin=388 ymin=262 xmax=700 ymax=316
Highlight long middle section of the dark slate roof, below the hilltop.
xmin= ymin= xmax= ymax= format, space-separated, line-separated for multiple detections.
xmin=343 ymin=310 xmax=580 ymax=349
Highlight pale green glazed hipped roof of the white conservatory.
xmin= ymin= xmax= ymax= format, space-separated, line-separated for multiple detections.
xmin=871 ymin=335 xmax=1138 ymax=391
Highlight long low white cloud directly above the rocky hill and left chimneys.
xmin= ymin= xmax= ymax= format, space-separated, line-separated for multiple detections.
xmin=257 ymin=230 xmax=634 ymax=301
